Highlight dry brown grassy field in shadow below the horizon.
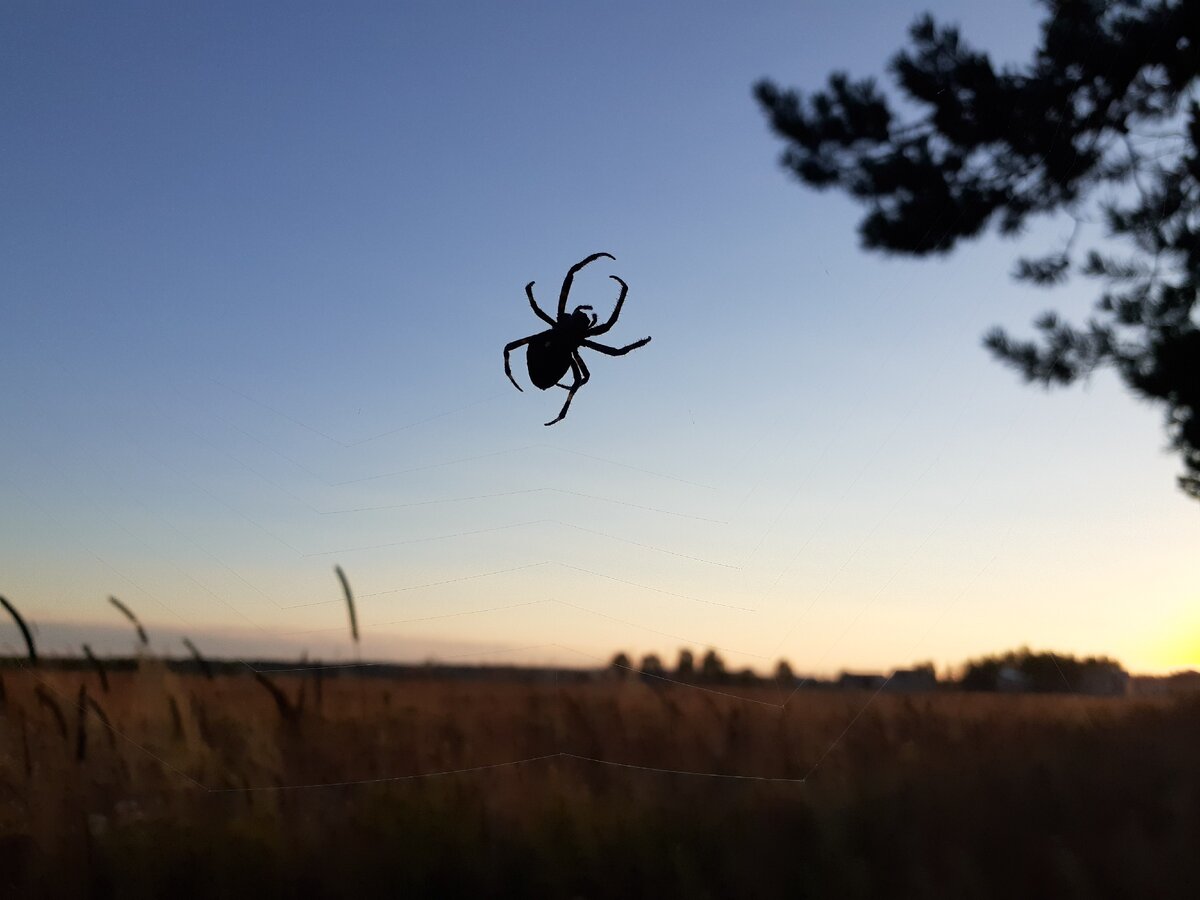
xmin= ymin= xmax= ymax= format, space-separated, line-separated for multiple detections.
xmin=0 ymin=661 xmax=1200 ymax=898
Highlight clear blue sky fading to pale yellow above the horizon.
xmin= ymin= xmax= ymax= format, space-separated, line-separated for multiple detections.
xmin=0 ymin=0 xmax=1200 ymax=674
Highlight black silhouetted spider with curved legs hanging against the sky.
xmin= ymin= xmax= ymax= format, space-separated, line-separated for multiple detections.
xmin=504 ymin=253 xmax=650 ymax=425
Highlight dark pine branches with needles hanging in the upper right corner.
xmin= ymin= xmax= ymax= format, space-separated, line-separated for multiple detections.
xmin=755 ymin=0 xmax=1200 ymax=499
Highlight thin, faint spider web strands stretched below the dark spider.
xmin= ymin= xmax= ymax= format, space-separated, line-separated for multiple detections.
xmin=13 ymin=224 xmax=1060 ymax=793
